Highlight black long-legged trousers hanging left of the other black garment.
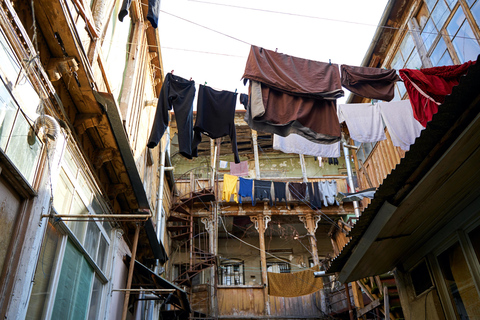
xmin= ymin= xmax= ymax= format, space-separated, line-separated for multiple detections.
xmin=147 ymin=73 xmax=195 ymax=159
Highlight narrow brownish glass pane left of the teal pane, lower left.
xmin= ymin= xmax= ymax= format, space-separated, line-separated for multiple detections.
xmin=25 ymin=223 xmax=60 ymax=320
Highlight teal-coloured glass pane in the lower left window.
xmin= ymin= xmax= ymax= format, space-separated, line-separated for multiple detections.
xmin=52 ymin=241 xmax=93 ymax=320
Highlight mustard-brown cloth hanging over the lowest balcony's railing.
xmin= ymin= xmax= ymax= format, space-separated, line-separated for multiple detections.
xmin=267 ymin=266 xmax=323 ymax=297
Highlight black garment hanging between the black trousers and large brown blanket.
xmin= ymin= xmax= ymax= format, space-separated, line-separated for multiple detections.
xmin=192 ymin=85 xmax=240 ymax=163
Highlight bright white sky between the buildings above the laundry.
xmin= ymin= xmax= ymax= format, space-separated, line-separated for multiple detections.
xmin=158 ymin=0 xmax=387 ymax=105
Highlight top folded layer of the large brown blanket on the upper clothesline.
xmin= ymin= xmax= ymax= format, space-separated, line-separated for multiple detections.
xmin=242 ymin=46 xmax=344 ymax=100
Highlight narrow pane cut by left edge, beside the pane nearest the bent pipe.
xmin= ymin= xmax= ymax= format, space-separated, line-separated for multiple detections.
xmin=0 ymin=81 xmax=18 ymax=151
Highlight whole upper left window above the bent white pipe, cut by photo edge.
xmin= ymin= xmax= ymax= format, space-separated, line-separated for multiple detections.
xmin=0 ymin=32 xmax=43 ymax=185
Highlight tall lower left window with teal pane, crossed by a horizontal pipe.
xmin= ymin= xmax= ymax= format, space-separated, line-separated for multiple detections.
xmin=27 ymin=146 xmax=111 ymax=319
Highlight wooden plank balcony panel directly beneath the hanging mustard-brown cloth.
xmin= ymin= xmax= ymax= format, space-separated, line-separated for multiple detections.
xmin=270 ymin=292 xmax=321 ymax=317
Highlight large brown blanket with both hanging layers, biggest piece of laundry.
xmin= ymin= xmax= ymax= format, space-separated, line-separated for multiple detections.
xmin=243 ymin=46 xmax=344 ymax=144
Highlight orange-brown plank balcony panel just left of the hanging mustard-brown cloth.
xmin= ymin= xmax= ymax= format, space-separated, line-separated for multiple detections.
xmin=217 ymin=287 xmax=265 ymax=316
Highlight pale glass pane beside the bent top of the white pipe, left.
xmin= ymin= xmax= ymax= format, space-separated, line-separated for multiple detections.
xmin=6 ymin=113 xmax=43 ymax=184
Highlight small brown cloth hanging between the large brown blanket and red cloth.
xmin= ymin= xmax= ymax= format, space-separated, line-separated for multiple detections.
xmin=340 ymin=64 xmax=401 ymax=101
